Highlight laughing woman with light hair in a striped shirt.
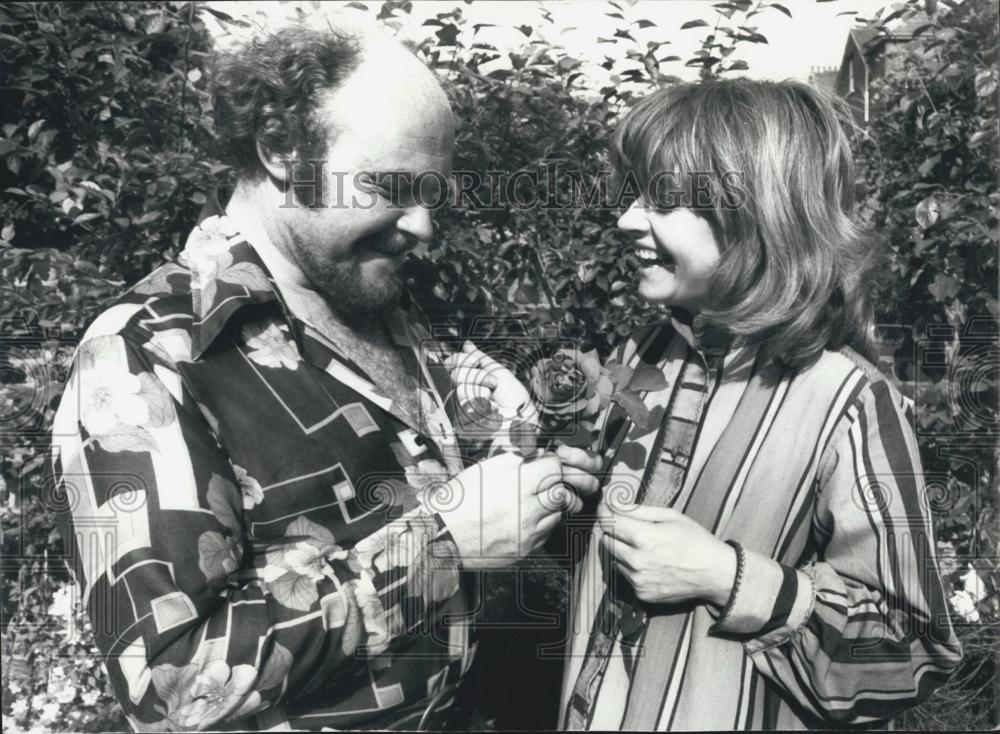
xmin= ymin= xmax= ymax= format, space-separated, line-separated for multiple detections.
xmin=454 ymin=80 xmax=961 ymax=730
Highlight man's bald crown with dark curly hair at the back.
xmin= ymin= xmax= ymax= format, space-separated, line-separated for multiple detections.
xmin=214 ymin=18 xmax=454 ymax=178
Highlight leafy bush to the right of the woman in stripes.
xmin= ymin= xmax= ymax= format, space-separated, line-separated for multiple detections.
xmin=860 ymin=0 xmax=1000 ymax=729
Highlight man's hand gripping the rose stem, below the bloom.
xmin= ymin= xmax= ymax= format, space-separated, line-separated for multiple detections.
xmin=421 ymin=454 xmax=579 ymax=568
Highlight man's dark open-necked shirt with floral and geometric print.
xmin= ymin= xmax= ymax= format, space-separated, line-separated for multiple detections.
xmin=53 ymin=216 xmax=472 ymax=730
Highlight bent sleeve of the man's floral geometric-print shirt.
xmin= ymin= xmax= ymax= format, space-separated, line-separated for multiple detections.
xmin=53 ymin=335 xmax=458 ymax=730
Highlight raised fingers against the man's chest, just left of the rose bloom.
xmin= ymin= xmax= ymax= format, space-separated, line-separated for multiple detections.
xmin=444 ymin=342 xmax=538 ymax=424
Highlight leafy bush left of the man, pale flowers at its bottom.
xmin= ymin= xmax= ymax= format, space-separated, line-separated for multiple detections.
xmin=0 ymin=2 xmax=224 ymax=731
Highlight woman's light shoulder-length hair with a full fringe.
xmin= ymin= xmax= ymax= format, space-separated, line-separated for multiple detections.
xmin=611 ymin=79 xmax=879 ymax=367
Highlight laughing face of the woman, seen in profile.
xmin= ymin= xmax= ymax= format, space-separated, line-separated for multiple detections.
xmin=618 ymin=198 xmax=719 ymax=313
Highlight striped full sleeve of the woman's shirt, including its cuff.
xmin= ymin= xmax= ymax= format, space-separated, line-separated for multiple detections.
xmin=713 ymin=377 xmax=961 ymax=724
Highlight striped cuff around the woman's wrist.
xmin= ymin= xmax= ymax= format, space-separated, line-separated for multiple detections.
xmin=711 ymin=549 xmax=816 ymax=653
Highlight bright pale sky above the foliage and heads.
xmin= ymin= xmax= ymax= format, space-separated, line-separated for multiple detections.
xmin=210 ymin=0 xmax=892 ymax=81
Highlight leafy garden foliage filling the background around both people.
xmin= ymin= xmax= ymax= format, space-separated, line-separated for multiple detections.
xmin=0 ymin=0 xmax=1000 ymax=731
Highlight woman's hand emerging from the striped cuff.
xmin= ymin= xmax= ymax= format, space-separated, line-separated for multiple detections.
xmin=597 ymin=502 xmax=736 ymax=607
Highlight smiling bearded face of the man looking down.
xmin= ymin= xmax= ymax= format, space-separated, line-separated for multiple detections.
xmin=283 ymin=65 xmax=454 ymax=320
